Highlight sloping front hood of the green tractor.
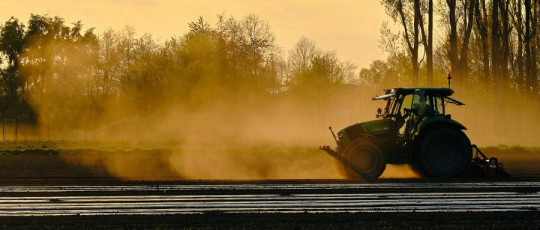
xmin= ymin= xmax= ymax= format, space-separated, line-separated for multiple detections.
xmin=338 ymin=119 xmax=394 ymax=144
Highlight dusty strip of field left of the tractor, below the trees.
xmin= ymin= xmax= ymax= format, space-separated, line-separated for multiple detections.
xmin=0 ymin=142 xmax=341 ymax=180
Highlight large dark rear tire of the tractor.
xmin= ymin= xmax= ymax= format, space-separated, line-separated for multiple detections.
xmin=414 ymin=126 xmax=472 ymax=178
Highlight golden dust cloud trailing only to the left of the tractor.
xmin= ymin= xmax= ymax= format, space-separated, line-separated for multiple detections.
xmin=21 ymin=28 xmax=375 ymax=180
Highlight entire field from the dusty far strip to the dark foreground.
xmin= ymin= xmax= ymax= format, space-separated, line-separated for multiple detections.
xmin=0 ymin=141 xmax=540 ymax=229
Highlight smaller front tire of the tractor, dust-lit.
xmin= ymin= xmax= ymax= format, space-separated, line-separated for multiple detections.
xmin=343 ymin=139 xmax=386 ymax=180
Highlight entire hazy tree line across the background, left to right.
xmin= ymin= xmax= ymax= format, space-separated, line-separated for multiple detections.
xmin=0 ymin=5 xmax=540 ymax=138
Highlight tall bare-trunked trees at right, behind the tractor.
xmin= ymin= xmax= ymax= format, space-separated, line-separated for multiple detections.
xmin=374 ymin=0 xmax=540 ymax=95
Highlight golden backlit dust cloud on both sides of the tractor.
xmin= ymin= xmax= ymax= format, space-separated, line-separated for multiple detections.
xmin=16 ymin=19 xmax=540 ymax=180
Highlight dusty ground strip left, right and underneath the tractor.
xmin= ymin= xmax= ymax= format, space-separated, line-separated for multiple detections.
xmin=0 ymin=146 xmax=540 ymax=183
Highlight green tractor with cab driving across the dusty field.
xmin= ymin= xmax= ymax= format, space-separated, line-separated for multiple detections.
xmin=321 ymin=88 xmax=502 ymax=180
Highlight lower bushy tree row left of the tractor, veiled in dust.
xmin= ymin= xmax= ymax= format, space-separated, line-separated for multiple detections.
xmin=0 ymin=14 xmax=355 ymax=131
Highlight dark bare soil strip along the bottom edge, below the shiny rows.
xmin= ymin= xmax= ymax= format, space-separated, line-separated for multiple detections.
xmin=0 ymin=212 xmax=540 ymax=229
